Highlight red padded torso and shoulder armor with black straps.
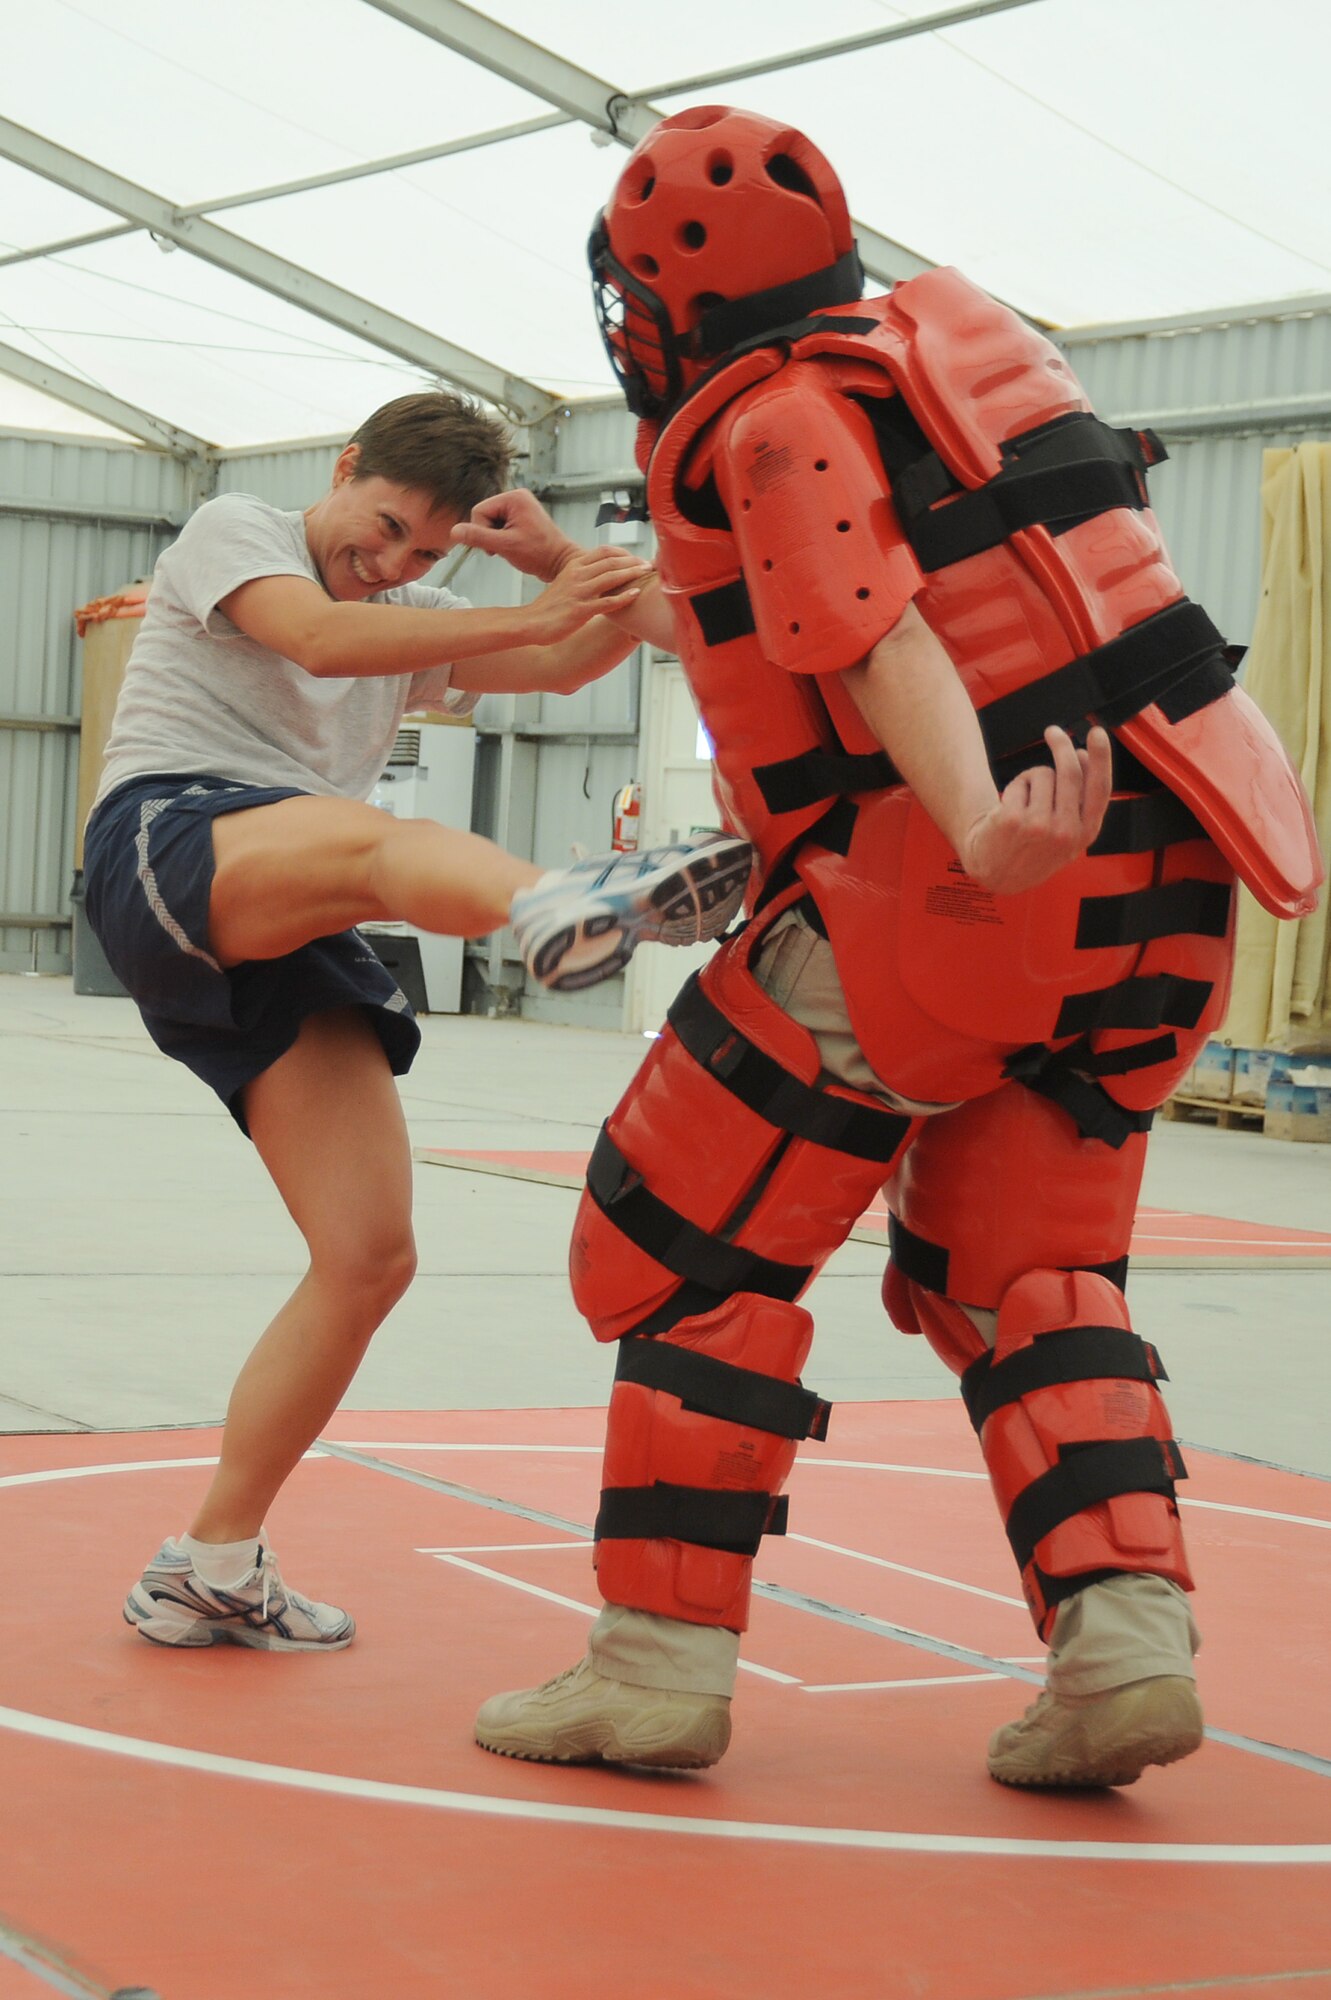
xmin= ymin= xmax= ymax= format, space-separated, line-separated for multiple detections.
xmin=650 ymin=270 xmax=1321 ymax=916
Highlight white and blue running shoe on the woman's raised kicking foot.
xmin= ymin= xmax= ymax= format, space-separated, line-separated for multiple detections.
xmin=510 ymin=834 xmax=753 ymax=992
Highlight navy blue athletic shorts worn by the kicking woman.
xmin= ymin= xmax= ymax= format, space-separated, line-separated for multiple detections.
xmin=84 ymin=774 xmax=420 ymax=1136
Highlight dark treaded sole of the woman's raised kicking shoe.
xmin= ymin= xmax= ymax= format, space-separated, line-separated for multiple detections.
xmin=532 ymin=840 xmax=753 ymax=992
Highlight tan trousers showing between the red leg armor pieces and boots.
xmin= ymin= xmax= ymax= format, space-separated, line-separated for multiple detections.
xmin=590 ymin=910 xmax=1201 ymax=1696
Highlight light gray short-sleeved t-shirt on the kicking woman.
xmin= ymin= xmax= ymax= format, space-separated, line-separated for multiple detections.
xmin=94 ymin=494 xmax=478 ymax=804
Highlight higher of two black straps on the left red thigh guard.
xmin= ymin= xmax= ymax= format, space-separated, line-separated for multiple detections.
xmin=666 ymin=972 xmax=911 ymax=1166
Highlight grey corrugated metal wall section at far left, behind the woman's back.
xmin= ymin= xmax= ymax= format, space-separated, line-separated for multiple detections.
xmin=0 ymin=432 xmax=196 ymax=972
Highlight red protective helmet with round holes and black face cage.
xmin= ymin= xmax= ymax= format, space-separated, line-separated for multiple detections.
xmin=588 ymin=104 xmax=863 ymax=418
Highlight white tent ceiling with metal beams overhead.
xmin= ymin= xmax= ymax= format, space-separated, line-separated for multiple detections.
xmin=0 ymin=0 xmax=1331 ymax=450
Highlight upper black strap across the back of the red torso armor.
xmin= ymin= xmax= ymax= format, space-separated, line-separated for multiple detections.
xmin=891 ymin=410 xmax=1153 ymax=570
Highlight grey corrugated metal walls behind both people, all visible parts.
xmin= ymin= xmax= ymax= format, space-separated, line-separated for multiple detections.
xmin=0 ymin=300 xmax=1331 ymax=984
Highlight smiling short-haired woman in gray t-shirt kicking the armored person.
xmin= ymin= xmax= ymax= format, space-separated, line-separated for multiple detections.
xmin=94 ymin=392 xmax=747 ymax=1650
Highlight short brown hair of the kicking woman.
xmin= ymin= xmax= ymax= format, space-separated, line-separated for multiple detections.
xmin=350 ymin=390 xmax=514 ymax=520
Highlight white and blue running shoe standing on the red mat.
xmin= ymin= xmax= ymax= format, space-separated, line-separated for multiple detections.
xmin=124 ymin=1538 xmax=356 ymax=1652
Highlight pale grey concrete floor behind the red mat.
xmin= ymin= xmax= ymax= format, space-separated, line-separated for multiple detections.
xmin=0 ymin=976 xmax=1331 ymax=1478
